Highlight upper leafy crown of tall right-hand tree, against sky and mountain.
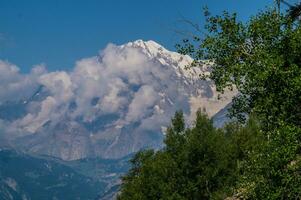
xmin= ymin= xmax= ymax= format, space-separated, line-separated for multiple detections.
xmin=177 ymin=10 xmax=301 ymax=128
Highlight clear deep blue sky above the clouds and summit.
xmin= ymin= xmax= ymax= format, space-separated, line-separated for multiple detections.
xmin=0 ymin=0 xmax=273 ymax=72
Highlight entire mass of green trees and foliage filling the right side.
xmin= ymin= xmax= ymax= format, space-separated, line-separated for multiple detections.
xmin=118 ymin=5 xmax=301 ymax=199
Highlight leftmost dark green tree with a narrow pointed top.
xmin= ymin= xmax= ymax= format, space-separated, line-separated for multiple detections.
xmin=118 ymin=112 xmax=185 ymax=200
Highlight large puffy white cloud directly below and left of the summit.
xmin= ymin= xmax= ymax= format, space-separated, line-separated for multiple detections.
xmin=67 ymin=44 xmax=173 ymax=121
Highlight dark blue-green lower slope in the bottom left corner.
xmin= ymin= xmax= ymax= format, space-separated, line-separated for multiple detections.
xmin=0 ymin=150 xmax=128 ymax=200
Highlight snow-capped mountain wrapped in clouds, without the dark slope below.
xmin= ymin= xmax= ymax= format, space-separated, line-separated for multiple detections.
xmin=0 ymin=40 xmax=236 ymax=160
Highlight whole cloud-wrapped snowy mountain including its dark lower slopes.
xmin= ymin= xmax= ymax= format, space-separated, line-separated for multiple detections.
xmin=0 ymin=40 xmax=236 ymax=199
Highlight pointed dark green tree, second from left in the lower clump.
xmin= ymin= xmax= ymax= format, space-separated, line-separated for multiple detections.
xmin=178 ymin=112 xmax=237 ymax=199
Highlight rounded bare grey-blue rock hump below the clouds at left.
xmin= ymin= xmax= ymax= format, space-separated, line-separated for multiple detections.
xmin=15 ymin=120 xmax=93 ymax=160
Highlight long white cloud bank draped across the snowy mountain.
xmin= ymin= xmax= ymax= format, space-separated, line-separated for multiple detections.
xmin=0 ymin=40 xmax=234 ymax=141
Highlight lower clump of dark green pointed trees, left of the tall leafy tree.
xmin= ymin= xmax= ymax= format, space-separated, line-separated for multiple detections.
xmin=118 ymin=112 xmax=260 ymax=200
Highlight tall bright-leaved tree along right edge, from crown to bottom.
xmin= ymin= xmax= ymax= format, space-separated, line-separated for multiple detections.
xmin=177 ymin=4 xmax=301 ymax=199
